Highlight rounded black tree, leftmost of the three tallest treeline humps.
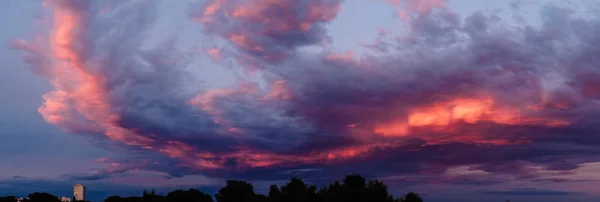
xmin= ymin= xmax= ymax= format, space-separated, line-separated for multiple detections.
xmin=215 ymin=180 xmax=255 ymax=202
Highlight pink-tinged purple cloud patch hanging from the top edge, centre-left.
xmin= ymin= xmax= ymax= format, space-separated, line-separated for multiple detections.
xmin=193 ymin=0 xmax=341 ymax=69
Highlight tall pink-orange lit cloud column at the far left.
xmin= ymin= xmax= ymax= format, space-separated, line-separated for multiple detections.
xmin=39 ymin=1 xmax=152 ymax=145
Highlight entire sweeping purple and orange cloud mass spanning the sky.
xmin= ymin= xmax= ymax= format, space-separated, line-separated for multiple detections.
xmin=14 ymin=0 xmax=600 ymax=189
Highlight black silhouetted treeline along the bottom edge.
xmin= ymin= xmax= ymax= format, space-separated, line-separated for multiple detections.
xmin=0 ymin=175 xmax=423 ymax=202
